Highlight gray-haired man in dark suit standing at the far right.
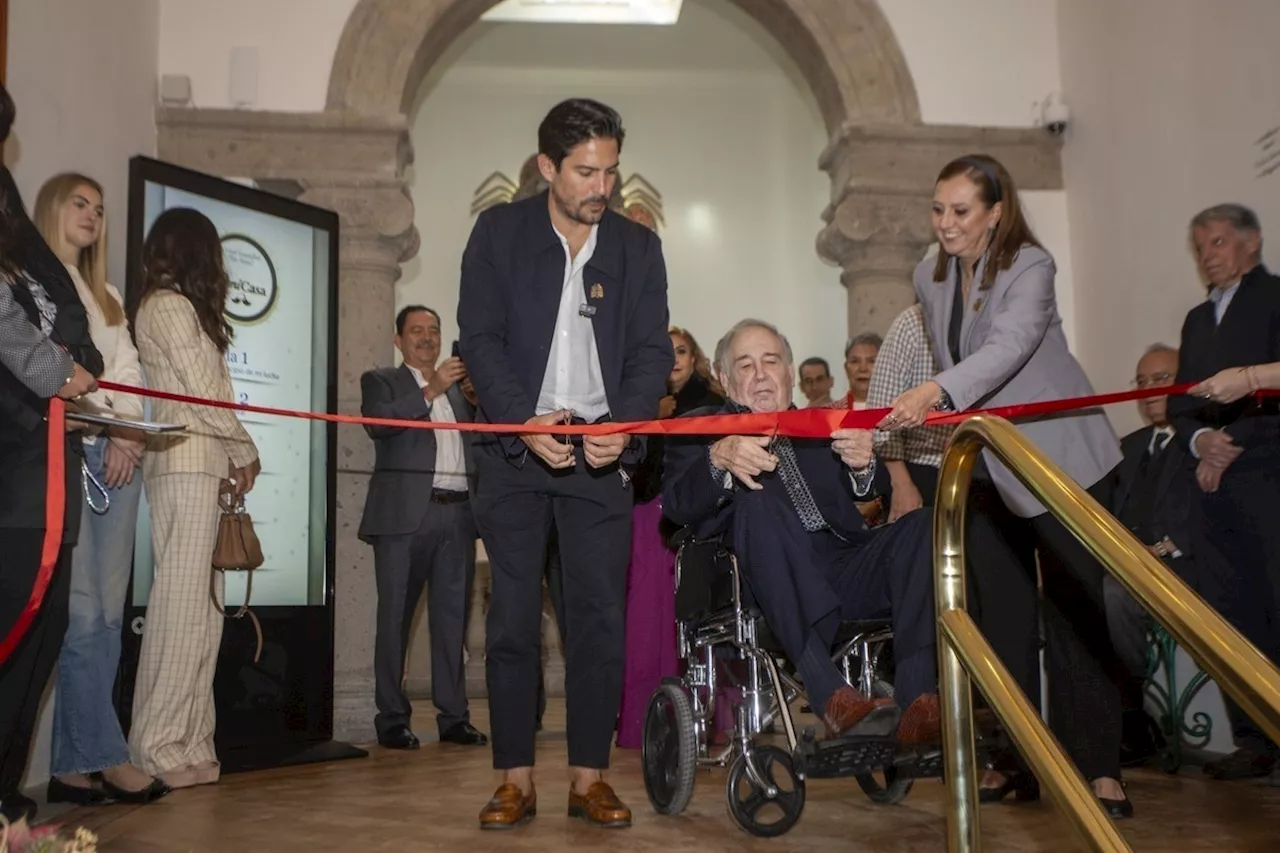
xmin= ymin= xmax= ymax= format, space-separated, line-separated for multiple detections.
xmin=1169 ymin=204 xmax=1280 ymax=779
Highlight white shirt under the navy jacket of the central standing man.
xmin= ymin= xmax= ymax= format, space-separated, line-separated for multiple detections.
xmin=536 ymin=225 xmax=609 ymax=423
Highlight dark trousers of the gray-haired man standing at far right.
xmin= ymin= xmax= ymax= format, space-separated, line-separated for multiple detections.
xmin=1202 ymin=452 xmax=1280 ymax=754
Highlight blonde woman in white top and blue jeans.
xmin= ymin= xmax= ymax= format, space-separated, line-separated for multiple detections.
xmin=35 ymin=174 xmax=169 ymax=806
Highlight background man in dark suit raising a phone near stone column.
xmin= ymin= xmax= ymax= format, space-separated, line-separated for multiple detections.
xmin=360 ymin=305 xmax=489 ymax=749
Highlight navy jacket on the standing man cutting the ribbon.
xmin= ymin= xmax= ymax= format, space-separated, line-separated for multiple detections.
xmin=458 ymin=192 xmax=676 ymax=462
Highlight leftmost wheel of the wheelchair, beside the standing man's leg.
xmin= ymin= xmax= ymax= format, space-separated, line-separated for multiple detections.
xmin=641 ymin=684 xmax=698 ymax=815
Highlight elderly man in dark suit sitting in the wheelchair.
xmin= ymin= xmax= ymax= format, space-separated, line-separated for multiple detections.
xmin=662 ymin=320 xmax=941 ymax=745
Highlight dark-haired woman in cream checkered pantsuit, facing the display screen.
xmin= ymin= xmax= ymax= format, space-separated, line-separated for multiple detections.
xmin=129 ymin=209 xmax=261 ymax=788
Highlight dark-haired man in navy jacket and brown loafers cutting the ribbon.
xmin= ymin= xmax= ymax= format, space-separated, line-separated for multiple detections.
xmin=458 ymin=99 xmax=675 ymax=829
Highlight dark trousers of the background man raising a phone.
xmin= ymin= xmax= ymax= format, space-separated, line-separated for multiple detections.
xmin=374 ymin=501 xmax=476 ymax=736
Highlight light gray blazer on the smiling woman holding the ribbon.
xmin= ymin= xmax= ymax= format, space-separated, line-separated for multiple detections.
xmin=914 ymin=246 xmax=1121 ymax=517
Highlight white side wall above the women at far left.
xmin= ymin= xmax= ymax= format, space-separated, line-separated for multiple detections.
xmin=4 ymin=0 xmax=159 ymax=785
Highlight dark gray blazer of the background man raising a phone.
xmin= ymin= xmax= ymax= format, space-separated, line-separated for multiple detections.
xmin=360 ymin=365 xmax=475 ymax=542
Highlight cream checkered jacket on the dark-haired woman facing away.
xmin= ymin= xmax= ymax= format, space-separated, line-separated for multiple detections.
xmin=136 ymin=291 xmax=257 ymax=479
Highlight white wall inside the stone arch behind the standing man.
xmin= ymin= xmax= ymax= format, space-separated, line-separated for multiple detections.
xmin=397 ymin=4 xmax=847 ymax=389
